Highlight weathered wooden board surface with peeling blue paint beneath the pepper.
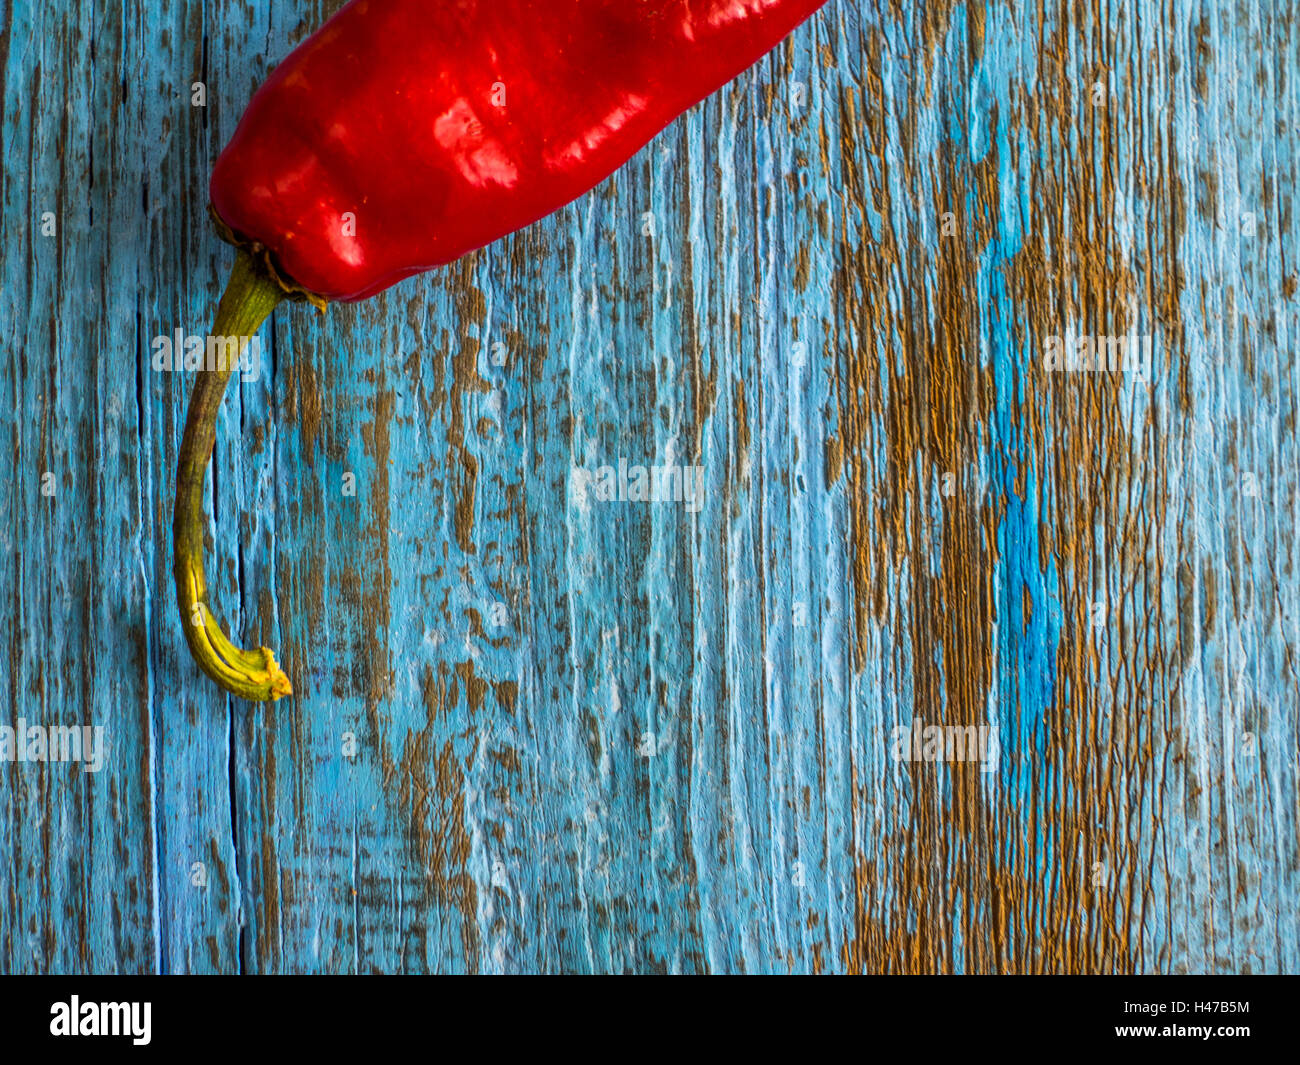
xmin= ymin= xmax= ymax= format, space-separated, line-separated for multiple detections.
xmin=0 ymin=0 xmax=1300 ymax=973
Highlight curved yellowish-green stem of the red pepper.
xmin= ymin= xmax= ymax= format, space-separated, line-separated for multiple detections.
xmin=172 ymin=250 xmax=293 ymax=702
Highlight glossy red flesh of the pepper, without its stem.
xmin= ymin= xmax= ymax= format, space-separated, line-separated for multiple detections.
xmin=211 ymin=0 xmax=824 ymax=300
